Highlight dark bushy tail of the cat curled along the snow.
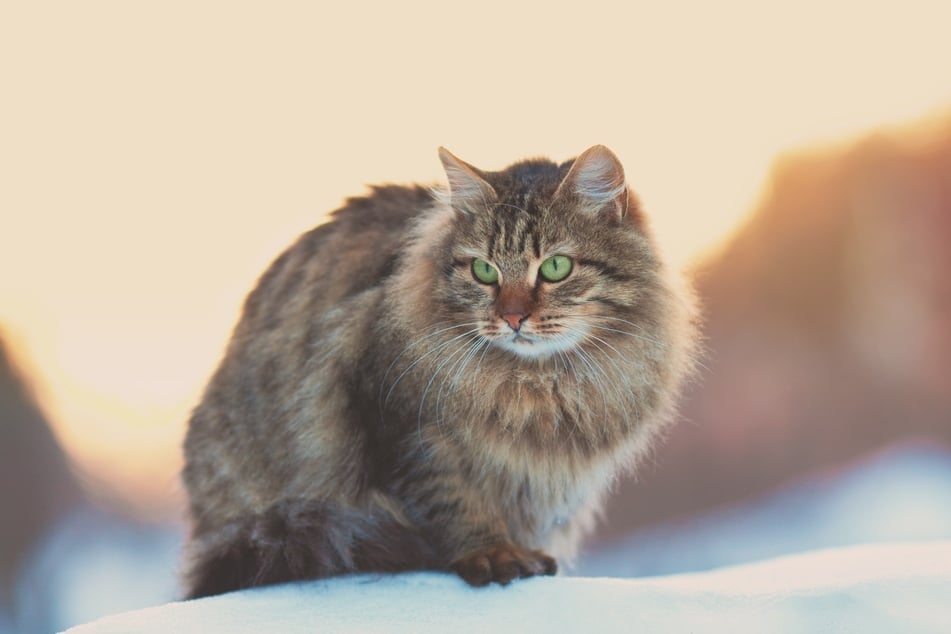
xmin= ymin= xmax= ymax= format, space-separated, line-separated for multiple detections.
xmin=185 ymin=500 xmax=437 ymax=599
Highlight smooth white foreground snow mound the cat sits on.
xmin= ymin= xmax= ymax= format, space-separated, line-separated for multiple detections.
xmin=69 ymin=541 xmax=951 ymax=634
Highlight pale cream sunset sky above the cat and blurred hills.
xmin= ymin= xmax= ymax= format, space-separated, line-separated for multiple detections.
xmin=0 ymin=1 xmax=951 ymax=508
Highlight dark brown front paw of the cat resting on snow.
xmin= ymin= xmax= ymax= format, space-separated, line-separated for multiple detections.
xmin=451 ymin=544 xmax=558 ymax=587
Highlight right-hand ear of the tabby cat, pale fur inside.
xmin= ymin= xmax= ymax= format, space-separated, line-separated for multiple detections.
xmin=555 ymin=145 xmax=629 ymax=219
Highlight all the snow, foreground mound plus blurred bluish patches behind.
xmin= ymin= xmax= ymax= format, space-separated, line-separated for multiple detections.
xmin=9 ymin=445 xmax=951 ymax=634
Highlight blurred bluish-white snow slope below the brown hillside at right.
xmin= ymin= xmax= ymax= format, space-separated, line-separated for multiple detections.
xmin=572 ymin=444 xmax=951 ymax=577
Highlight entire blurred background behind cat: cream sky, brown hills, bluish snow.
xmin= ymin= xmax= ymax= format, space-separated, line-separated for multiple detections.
xmin=0 ymin=1 xmax=951 ymax=634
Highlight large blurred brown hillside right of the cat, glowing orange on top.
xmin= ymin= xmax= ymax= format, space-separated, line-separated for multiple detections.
xmin=600 ymin=108 xmax=951 ymax=539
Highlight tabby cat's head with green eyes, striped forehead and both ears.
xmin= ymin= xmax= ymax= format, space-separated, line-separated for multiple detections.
xmin=437 ymin=145 xmax=659 ymax=359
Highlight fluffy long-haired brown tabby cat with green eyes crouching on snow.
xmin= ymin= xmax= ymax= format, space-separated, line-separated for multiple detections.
xmin=183 ymin=145 xmax=696 ymax=598
